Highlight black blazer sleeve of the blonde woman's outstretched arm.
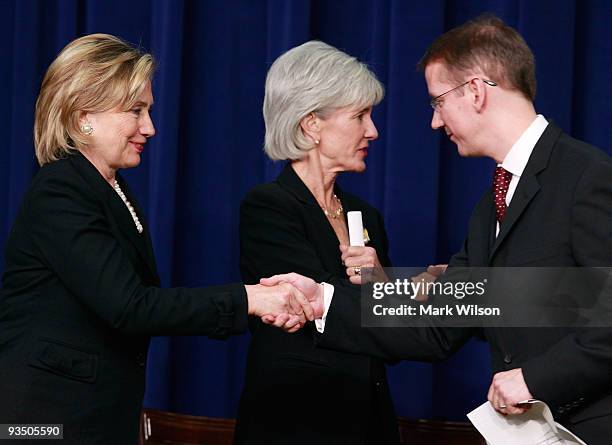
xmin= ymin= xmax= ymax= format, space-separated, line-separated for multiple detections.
xmin=22 ymin=168 xmax=247 ymax=337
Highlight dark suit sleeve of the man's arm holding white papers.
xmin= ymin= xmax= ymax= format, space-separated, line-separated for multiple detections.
xmin=522 ymin=159 xmax=612 ymax=404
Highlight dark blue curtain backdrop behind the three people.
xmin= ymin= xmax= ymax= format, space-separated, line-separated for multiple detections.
xmin=0 ymin=0 xmax=612 ymax=419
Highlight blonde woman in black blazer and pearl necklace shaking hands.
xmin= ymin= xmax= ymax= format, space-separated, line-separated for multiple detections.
xmin=0 ymin=34 xmax=320 ymax=444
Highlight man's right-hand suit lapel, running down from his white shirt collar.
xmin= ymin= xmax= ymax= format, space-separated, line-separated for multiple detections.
xmin=489 ymin=123 xmax=561 ymax=261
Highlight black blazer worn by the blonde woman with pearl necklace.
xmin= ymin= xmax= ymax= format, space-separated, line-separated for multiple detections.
xmin=0 ymin=153 xmax=247 ymax=444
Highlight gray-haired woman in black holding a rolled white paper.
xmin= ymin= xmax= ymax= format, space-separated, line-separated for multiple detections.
xmin=236 ymin=41 xmax=399 ymax=445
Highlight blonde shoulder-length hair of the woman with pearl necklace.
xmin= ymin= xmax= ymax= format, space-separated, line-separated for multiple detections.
xmin=34 ymin=34 xmax=155 ymax=165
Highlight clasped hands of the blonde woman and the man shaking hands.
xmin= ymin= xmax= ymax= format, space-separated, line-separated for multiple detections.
xmin=245 ymin=273 xmax=324 ymax=332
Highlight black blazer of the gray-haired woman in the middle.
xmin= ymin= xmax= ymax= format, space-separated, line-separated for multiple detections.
xmin=236 ymin=165 xmax=398 ymax=445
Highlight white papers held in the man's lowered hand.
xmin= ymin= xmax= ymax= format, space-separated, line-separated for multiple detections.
xmin=467 ymin=400 xmax=587 ymax=445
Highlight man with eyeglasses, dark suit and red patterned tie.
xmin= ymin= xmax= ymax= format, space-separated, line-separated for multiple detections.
xmin=270 ymin=15 xmax=612 ymax=445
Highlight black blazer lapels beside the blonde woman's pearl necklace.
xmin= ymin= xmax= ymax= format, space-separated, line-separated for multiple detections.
xmin=70 ymin=153 xmax=158 ymax=281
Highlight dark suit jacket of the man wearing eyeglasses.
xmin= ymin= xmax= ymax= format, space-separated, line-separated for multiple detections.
xmin=320 ymin=124 xmax=612 ymax=444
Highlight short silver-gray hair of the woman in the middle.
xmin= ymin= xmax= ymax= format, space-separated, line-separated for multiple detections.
xmin=263 ymin=40 xmax=385 ymax=160
